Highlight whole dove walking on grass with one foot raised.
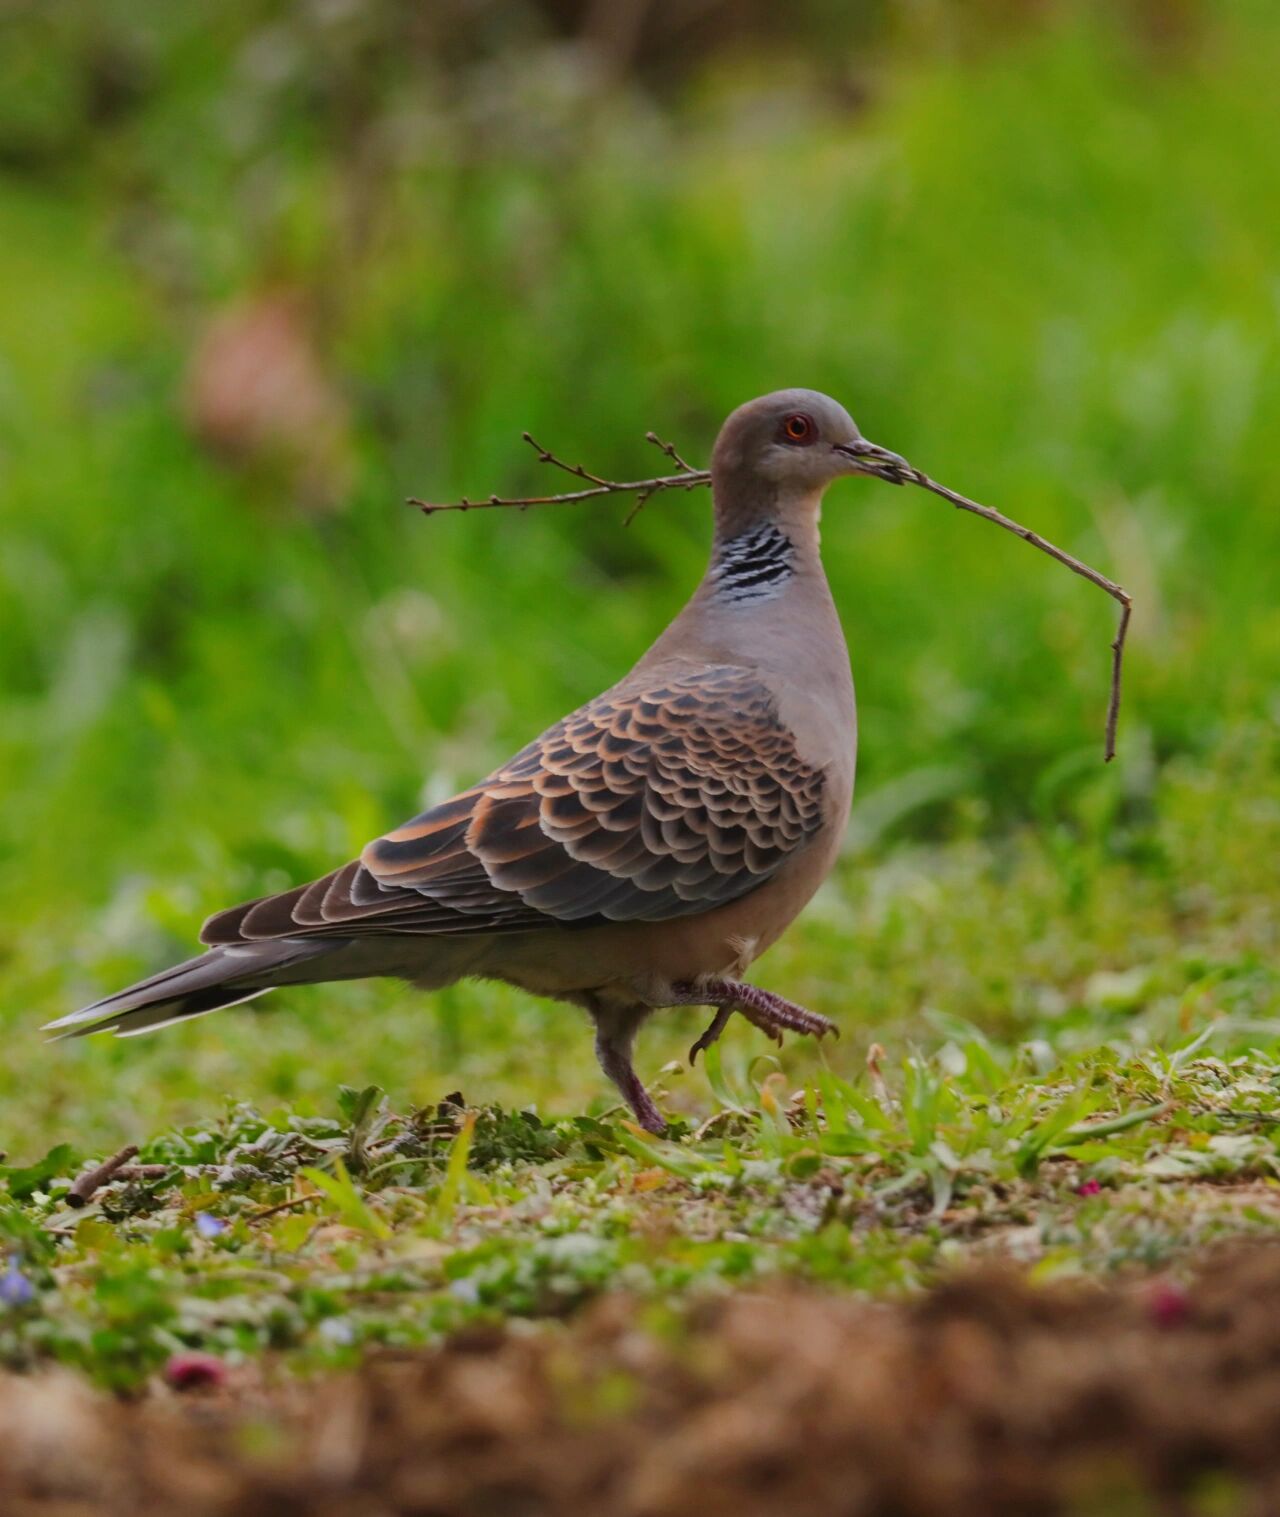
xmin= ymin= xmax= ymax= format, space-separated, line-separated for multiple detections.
xmin=50 ymin=390 xmax=898 ymax=1130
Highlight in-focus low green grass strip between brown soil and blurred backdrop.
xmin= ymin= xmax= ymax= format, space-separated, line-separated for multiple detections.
xmin=0 ymin=1019 xmax=1280 ymax=1390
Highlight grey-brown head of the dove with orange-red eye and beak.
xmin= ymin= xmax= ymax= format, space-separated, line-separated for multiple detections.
xmin=711 ymin=390 xmax=910 ymax=530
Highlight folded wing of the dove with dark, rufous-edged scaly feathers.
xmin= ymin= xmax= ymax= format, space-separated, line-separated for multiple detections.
xmin=202 ymin=666 xmax=825 ymax=944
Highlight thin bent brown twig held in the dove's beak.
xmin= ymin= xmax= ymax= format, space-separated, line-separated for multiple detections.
xmin=408 ymin=432 xmax=1133 ymax=763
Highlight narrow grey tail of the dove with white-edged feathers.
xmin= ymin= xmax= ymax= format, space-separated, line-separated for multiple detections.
xmin=44 ymin=938 xmax=344 ymax=1038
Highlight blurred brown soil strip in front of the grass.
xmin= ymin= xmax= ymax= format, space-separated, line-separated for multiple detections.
xmin=0 ymin=1248 xmax=1280 ymax=1517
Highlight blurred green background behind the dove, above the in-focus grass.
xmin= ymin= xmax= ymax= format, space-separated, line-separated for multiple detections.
xmin=0 ymin=0 xmax=1280 ymax=1151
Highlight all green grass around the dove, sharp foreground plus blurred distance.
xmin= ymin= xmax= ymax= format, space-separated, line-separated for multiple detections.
xmin=0 ymin=0 xmax=1280 ymax=1385
